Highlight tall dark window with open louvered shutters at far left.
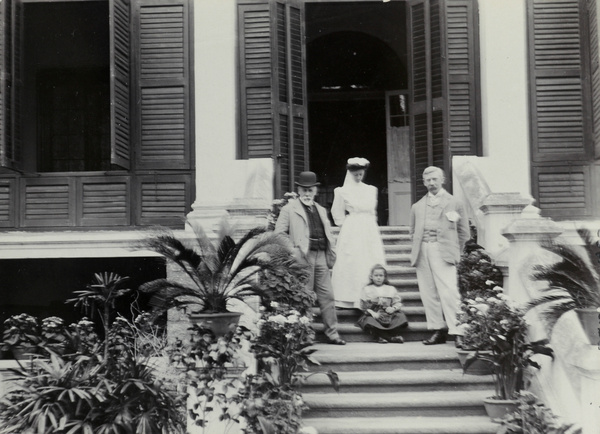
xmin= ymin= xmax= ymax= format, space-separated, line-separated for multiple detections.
xmin=0 ymin=0 xmax=194 ymax=228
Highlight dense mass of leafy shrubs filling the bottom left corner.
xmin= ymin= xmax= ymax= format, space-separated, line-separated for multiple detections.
xmin=0 ymin=273 xmax=185 ymax=434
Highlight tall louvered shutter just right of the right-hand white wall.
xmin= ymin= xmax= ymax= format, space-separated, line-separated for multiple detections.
xmin=528 ymin=0 xmax=598 ymax=218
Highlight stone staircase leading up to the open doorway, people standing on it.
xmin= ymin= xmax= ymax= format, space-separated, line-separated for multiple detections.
xmin=303 ymin=227 xmax=498 ymax=434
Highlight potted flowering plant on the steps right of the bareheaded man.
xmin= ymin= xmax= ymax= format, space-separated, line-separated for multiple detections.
xmin=459 ymin=287 xmax=553 ymax=399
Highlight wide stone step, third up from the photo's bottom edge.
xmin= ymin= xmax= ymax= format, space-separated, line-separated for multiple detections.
xmin=302 ymin=369 xmax=494 ymax=395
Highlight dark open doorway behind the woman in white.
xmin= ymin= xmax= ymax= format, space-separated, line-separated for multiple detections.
xmin=306 ymin=1 xmax=410 ymax=225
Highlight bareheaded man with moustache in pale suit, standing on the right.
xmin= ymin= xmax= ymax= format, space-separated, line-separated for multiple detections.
xmin=410 ymin=166 xmax=470 ymax=347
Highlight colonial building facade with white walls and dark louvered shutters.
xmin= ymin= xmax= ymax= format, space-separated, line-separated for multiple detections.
xmin=0 ymin=0 xmax=600 ymax=326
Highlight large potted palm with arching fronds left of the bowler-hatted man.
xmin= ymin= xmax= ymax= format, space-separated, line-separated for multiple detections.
xmin=140 ymin=221 xmax=298 ymax=335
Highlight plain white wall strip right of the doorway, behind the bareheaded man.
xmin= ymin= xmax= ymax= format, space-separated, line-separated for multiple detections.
xmin=454 ymin=0 xmax=530 ymax=194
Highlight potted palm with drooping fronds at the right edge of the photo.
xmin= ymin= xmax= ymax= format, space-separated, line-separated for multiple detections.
xmin=527 ymin=229 xmax=600 ymax=344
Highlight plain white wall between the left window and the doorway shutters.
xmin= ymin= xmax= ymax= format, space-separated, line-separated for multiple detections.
xmin=193 ymin=0 xmax=272 ymax=215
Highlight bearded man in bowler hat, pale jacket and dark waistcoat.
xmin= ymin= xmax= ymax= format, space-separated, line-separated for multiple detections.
xmin=275 ymin=172 xmax=346 ymax=345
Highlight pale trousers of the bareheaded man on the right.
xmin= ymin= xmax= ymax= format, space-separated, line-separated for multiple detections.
xmin=416 ymin=242 xmax=463 ymax=335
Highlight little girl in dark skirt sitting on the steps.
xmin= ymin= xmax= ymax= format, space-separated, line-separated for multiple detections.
xmin=358 ymin=264 xmax=408 ymax=344
